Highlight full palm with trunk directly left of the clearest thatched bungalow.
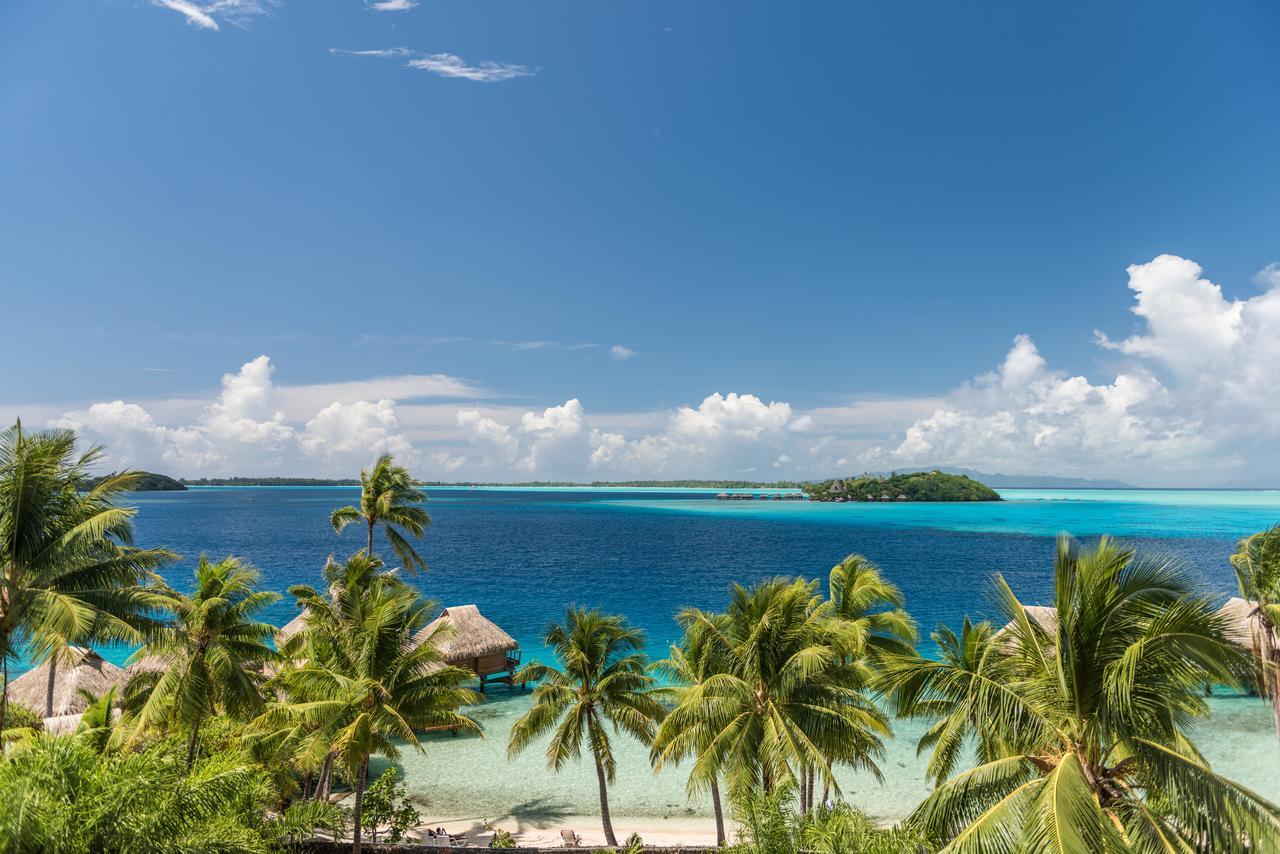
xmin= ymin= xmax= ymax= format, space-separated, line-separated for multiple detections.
xmin=264 ymin=553 xmax=480 ymax=853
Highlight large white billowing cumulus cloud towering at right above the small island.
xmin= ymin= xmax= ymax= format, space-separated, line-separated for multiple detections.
xmin=860 ymin=255 xmax=1280 ymax=483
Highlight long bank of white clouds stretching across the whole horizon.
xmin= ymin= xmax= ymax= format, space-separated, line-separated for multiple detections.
xmin=40 ymin=255 xmax=1280 ymax=485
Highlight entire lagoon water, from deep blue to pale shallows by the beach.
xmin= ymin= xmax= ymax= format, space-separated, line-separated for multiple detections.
xmin=82 ymin=487 xmax=1280 ymax=819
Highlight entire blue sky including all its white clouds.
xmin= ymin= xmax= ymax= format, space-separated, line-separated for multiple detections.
xmin=0 ymin=0 xmax=1280 ymax=487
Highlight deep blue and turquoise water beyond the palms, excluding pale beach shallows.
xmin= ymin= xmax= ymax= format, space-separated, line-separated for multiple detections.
xmin=119 ymin=488 xmax=1280 ymax=659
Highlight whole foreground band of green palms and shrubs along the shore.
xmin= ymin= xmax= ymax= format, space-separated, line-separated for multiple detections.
xmin=0 ymin=425 xmax=1280 ymax=854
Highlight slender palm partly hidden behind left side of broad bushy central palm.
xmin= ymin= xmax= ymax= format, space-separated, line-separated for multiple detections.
xmin=650 ymin=632 xmax=726 ymax=845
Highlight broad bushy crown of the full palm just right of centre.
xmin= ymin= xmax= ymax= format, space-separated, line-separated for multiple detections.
xmin=663 ymin=577 xmax=891 ymax=798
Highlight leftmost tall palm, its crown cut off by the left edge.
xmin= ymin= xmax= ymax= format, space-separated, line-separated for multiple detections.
xmin=0 ymin=421 xmax=174 ymax=731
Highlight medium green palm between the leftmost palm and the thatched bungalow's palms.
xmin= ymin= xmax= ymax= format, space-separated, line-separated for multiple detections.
xmin=128 ymin=556 xmax=280 ymax=767
